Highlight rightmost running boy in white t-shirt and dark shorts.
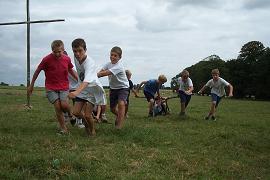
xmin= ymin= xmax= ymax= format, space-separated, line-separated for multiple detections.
xmin=198 ymin=69 xmax=233 ymax=121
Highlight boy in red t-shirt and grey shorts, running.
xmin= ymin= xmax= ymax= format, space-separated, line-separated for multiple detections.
xmin=27 ymin=40 xmax=78 ymax=134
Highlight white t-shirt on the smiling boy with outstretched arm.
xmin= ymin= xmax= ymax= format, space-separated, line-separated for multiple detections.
xmin=102 ymin=61 xmax=129 ymax=89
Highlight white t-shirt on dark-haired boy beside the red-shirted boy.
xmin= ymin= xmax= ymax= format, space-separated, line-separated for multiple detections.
xmin=74 ymin=56 xmax=104 ymax=94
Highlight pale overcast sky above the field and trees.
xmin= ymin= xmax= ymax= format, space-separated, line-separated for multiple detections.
xmin=0 ymin=0 xmax=270 ymax=86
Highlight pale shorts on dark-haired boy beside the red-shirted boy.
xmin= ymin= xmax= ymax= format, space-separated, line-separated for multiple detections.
xmin=77 ymin=86 xmax=107 ymax=105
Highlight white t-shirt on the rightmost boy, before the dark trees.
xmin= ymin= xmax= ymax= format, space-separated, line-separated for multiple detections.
xmin=205 ymin=77 xmax=229 ymax=97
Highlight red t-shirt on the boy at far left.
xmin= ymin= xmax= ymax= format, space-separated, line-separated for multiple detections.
xmin=38 ymin=53 xmax=73 ymax=91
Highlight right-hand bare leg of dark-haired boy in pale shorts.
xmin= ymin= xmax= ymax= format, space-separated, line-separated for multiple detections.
xmin=84 ymin=103 xmax=96 ymax=136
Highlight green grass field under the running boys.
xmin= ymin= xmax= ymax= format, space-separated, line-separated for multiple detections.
xmin=0 ymin=87 xmax=270 ymax=179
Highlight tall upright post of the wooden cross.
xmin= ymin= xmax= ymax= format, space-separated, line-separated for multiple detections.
xmin=26 ymin=0 xmax=30 ymax=107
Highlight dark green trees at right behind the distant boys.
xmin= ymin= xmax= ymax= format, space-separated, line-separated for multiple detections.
xmin=171 ymin=41 xmax=270 ymax=100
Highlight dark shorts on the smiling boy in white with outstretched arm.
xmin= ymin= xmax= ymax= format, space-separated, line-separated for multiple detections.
xmin=110 ymin=88 xmax=129 ymax=108
